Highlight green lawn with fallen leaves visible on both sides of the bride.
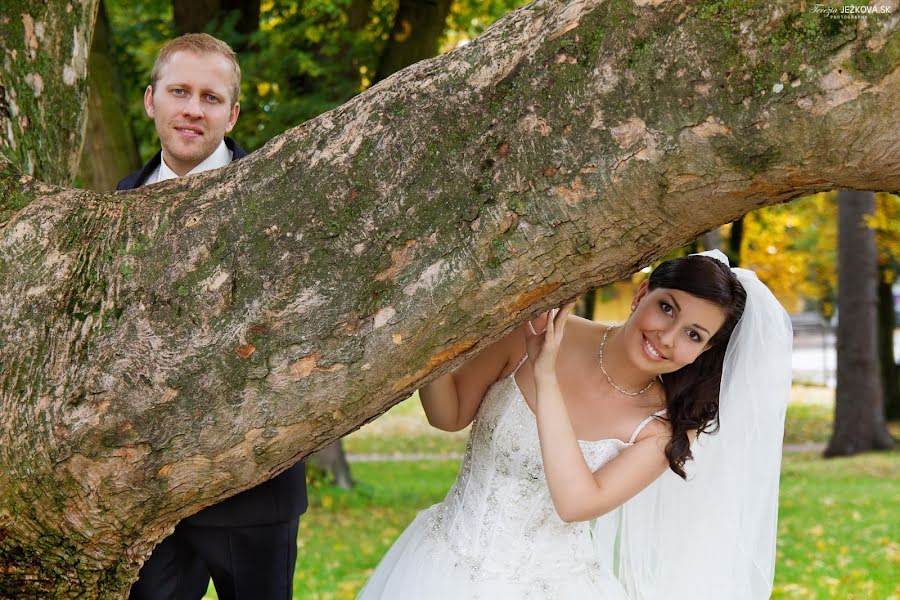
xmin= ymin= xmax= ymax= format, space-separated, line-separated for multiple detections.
xmin=207 ymin=386 xmax=900 ymax=600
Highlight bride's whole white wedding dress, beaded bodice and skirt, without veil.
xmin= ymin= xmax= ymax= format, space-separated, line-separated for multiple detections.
xmin=357 ymin=359 xmax=663 ymax=600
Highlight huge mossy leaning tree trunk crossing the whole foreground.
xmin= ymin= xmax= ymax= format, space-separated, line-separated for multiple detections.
xmin=0 ymin=0 xmax=900 ymax=597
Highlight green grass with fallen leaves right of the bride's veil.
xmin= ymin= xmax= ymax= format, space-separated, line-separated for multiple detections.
xmin=772 ymin=451 xmax=900 ymax=600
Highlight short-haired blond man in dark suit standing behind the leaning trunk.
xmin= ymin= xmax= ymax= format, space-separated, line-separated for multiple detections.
xmin=118 ymin=34 xmax=307 ymax=600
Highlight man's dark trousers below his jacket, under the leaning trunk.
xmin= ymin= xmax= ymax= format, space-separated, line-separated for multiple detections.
xmin=129 ymin=517 xmax=300 ymax=600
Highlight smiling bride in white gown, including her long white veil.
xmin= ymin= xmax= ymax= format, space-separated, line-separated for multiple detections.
xmin=359 ymin=251 xmax=791 ymax=600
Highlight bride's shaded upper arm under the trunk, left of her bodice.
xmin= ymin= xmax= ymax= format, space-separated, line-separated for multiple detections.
xmin=419 ymin=320 xmax=540 ymax=431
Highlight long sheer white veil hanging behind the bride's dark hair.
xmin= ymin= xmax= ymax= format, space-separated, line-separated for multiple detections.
xmin=593 ymin=250 xmax=792 ymax=600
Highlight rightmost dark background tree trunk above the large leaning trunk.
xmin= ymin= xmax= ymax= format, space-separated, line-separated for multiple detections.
xmin=373 ymin=0 xmax=451 ymax=83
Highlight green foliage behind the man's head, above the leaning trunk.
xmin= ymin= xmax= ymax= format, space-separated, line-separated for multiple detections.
xmin=107 ymin=0 xmax=525 ymax=158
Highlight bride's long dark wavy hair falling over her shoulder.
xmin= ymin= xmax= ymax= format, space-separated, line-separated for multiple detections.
xmin=648 ymin=255 xmax=747 ymax=479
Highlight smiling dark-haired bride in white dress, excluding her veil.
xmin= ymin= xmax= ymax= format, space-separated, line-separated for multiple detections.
xmin=359 ymin=255 xmax=783 ymax=600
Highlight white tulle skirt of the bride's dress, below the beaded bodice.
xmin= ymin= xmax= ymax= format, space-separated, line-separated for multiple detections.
xmin=357 ymin=504 xmax=628 ymax=600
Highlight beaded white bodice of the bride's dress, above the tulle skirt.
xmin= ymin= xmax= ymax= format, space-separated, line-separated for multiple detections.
xmin=418 ymin=374 xmax=631 ymax=581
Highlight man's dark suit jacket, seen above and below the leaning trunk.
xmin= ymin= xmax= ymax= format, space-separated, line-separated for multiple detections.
xmin=116 ymin=138 xmax=307 ymax=527
